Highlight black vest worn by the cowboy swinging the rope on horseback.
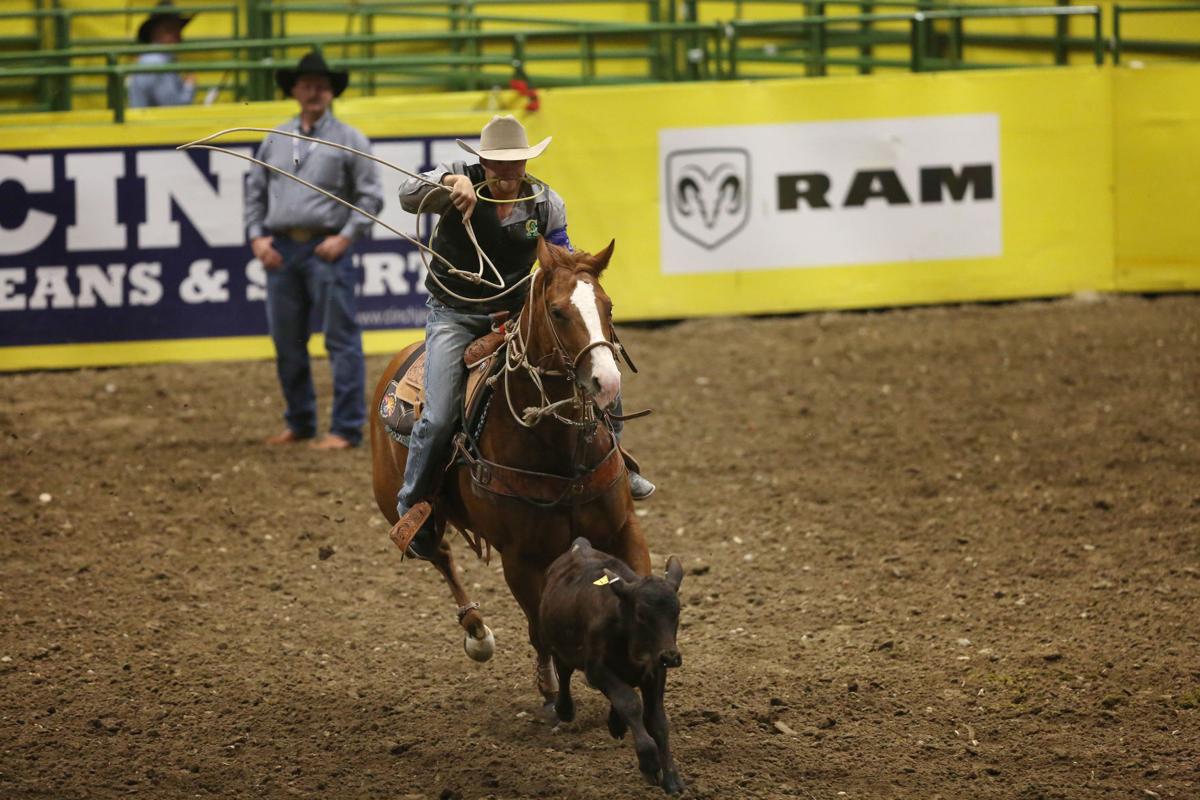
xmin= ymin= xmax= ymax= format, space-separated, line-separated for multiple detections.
xmin=425 ymin=164 xmax=550 ymax=314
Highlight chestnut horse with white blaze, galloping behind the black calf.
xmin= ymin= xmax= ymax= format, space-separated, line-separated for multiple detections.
xmin=371 ymin=240 xmax=650 ymax=703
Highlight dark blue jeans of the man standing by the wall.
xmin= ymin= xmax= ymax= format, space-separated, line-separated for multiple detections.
xmin=266 ymin=236 xmax=366 ymax=445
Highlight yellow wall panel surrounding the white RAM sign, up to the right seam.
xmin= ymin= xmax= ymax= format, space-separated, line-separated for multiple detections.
xmin=530 ymin=68 xmax=1114 ymax=319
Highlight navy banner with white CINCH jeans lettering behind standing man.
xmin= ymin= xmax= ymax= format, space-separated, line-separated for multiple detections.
xmin=0 ymin=137 xmax=472 ymax=348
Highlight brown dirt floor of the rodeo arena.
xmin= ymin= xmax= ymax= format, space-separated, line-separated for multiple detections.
xmin=0 ymin=296 xmax=1200 ymax=800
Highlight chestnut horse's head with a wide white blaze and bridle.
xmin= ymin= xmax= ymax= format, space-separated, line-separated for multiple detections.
xmin=527 ymin=239 xmax=620 ymax=408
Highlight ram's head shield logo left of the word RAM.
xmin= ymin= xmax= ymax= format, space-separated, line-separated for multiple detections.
xmin=666 ymin=148 xmax=750 ymax=249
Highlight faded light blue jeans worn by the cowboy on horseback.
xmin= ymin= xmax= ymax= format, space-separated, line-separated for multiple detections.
xmin=396 ymin=297 xmax=638 ymax=517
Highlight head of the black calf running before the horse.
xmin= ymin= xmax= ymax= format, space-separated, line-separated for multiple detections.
xmin=610 ymin=555 xmax=683 ymax=669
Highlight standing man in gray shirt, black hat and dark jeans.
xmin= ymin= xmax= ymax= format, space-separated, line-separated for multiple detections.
xmin=245 ymin=53 xmax=383 ymax=450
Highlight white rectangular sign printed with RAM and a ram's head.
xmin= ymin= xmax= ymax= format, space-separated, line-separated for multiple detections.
xmin=659 ymin=114 xmax=1003 ymax=273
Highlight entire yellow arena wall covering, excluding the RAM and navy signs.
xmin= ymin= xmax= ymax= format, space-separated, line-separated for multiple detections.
xmin=0 ymin=67 xmax=1200 ymax=371
